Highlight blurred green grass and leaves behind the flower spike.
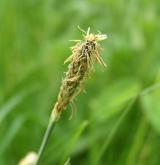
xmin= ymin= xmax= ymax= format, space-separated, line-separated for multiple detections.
xmin=0 ymin=0 xmax=160 ymax=165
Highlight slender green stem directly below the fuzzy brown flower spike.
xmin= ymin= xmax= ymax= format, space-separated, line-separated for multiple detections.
xmin=35 ymin=115 xmax=57 ymax=165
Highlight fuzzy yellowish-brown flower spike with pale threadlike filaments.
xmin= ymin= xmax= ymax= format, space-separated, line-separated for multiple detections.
xmin=51 ymin=27 xmax=107 ymax=120
